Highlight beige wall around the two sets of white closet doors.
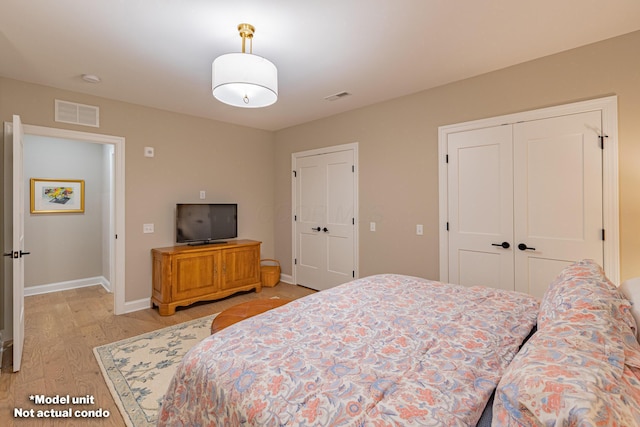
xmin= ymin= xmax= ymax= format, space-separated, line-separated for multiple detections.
xmin=276 ymin=32 xmax=640 ymax=280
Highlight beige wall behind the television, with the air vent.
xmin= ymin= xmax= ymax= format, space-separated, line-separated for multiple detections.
xmin=0 ymin=78 xmax=274 ymax=307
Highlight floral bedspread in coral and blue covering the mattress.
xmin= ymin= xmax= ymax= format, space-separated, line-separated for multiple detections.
xmin=158 ymin=275 xmax=539 ymax=426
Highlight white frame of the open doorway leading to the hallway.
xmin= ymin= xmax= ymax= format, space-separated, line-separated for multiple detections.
xmin=16 ymin=124 xmax=125 ymax=314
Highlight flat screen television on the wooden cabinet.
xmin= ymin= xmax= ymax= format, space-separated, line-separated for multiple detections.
xmin=176 ymin=203 xmax=238 ymax=245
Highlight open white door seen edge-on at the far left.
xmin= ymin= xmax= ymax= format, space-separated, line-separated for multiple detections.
xmin=11 ymin=115 xmax=27 ymax=372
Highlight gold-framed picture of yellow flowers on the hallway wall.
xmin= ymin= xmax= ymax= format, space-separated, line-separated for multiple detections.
xmin=31 ymin=178 xmax=84 ymax=214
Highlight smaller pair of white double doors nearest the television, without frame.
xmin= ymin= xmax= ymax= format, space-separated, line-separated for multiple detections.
xmin=294 ymin=149 xmax=356 ymax=290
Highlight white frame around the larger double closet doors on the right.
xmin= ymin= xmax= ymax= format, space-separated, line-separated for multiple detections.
xmin=438 ymin=96 xmax=620 ymax=285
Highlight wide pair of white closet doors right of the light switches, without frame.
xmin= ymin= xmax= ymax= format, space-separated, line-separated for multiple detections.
xmin=447 ymin=111 xmax=604 ymax=297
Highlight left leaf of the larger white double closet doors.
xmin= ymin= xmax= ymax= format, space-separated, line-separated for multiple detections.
xmin=447 ymin=125 xmax=514 ymax=290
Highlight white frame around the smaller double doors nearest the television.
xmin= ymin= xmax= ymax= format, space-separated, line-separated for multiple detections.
xmin=291 ymin=142 xmax=360 ymax=284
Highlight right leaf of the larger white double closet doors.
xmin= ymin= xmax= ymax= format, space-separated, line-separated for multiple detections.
xmin=514 ymin=111 xmax=604 ymax=297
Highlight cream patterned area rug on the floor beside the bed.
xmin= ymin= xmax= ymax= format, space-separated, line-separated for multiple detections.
xmin=93 ymin=314 xmax=216 ymax=427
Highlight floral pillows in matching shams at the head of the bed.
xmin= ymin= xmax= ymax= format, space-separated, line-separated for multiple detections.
xmin=492 ymin=260 xmax=640 ymax=427
